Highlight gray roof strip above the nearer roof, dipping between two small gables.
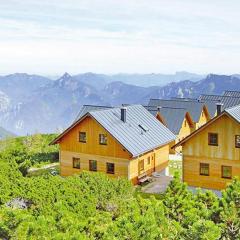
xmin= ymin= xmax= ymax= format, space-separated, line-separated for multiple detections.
xmin=148 ymin=99 xmax=204 ymax=122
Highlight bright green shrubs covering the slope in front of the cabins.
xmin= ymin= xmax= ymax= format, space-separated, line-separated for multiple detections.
xmin=0 ymin=135 xmax=240 ymax=240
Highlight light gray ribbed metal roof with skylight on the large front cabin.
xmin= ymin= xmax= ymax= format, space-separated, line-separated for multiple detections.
xmin=89 ymin=105 xmax=176 ymax=157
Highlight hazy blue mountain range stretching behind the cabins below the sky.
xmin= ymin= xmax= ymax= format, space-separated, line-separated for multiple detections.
xmin=0 ymin=73 xmax=240 ymax=135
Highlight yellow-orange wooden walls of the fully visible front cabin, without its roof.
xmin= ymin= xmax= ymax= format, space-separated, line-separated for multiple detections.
xmin=58 ymin=116 xmax=169 ymax=184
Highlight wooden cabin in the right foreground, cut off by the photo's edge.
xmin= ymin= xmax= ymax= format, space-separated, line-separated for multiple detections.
xmin=174 ymin=105 xmax=240 ymax=190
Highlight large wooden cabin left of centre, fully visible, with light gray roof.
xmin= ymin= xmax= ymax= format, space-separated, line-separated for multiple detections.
xmin=52 ymin=105 xmax=175 ymax=184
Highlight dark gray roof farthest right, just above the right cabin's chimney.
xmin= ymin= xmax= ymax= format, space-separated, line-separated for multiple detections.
xmin=199 ymin=94 xmax=240 ymax=110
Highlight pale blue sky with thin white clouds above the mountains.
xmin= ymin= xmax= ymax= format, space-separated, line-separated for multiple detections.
xmin=0 ymin=0 xmax=240 ymax=75
